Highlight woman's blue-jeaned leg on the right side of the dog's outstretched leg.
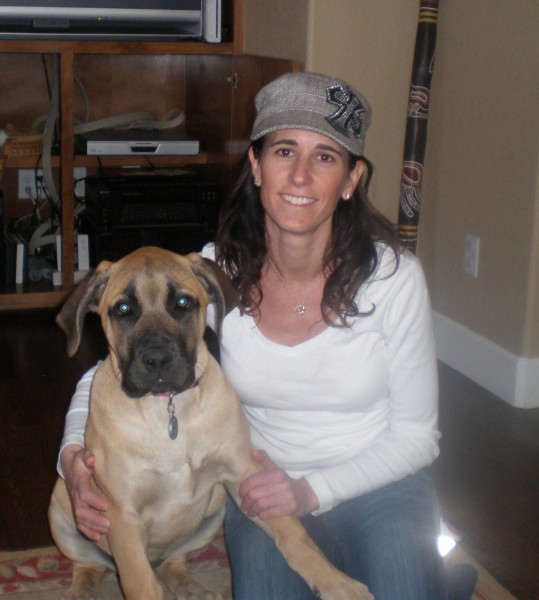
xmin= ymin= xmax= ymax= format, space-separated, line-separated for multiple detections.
xmin=331 ymin=473 xmax=446 ymax=600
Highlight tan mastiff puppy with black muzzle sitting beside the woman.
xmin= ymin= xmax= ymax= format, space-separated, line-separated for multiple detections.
xmin=49 ymin=247 xmax=372 ymax=600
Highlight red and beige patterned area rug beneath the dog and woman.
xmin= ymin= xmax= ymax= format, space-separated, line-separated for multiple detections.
xmin=0 ymin=536 xmax=516 ymax=600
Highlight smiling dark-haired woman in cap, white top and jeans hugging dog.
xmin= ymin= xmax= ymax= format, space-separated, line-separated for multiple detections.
xmin=61 ymin=73 xmax=469 ymax=600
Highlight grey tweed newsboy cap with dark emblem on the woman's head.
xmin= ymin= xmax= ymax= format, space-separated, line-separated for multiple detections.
xmin=251 ymin=73 xmax=371 ymax=156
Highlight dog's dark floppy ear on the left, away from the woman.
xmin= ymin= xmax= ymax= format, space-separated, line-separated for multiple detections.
xmin=56 ymin=261 xmax=111 ymax=356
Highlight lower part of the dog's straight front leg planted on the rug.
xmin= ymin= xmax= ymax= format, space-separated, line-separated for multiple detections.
xmin=107 ymin=508 xmax=163 ymax=600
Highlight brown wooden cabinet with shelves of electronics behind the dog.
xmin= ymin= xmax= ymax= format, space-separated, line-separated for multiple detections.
xmin=0 ymin=0 xmax=298 ymax=310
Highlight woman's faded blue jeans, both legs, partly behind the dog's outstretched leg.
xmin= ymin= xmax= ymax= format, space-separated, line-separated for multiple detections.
xmin=225 ymin=472 xmax=447 ymax=600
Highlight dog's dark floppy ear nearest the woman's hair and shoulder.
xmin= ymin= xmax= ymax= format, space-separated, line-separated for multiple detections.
xmin=186 ymin=252 xmax=239 ymax=324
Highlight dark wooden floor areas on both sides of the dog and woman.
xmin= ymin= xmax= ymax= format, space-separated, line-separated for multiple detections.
xmin=0 ymin=310 xmax=539 ymax=600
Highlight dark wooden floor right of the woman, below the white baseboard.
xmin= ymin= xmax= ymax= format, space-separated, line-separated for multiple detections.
xmin=431 ymin=364 xmax=539 ymax=600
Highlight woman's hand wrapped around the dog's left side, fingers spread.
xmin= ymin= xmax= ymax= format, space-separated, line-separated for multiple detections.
xmin=61 ymin=444 xmax=110 ymax=542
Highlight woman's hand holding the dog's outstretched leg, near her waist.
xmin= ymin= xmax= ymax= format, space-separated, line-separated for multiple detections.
xmin=240 ymin=450 xmax=318 ymax=521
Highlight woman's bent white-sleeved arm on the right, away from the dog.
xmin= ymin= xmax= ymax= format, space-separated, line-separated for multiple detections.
xmin=306 ymin=256 xmax=440 ymax=512
